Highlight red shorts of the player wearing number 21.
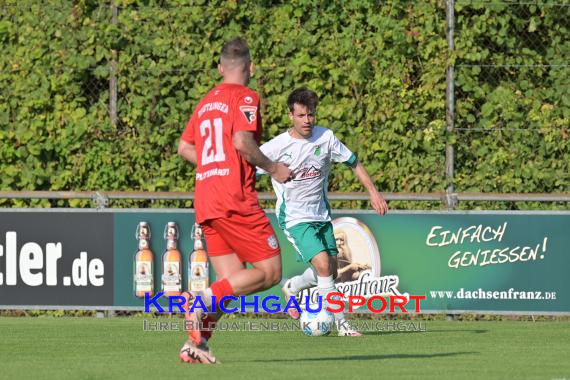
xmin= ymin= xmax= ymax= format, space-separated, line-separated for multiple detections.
xmin=200 ymin=210 xmax=281 ymax=263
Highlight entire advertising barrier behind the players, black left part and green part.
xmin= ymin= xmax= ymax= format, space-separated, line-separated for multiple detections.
xmin=0 ymin=209 xmax=570 ymax=315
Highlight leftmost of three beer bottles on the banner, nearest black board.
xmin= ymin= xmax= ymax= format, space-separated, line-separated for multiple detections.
xmin=133 ymin=222 xmax=154 ymax=298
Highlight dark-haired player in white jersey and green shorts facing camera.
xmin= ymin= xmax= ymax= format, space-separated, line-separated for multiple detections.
xmin=261 ymin=88 xmax=388 ymax=336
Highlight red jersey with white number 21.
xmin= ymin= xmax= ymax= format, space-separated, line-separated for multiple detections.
xmin=182 ymin=83 xmax=261 ymax=223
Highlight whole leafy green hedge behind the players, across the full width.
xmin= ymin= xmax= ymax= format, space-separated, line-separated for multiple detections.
xmin=0 ymin=0 xmax=570 ymax=208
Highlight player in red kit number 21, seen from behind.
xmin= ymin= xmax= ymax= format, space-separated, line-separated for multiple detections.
xmin=178 ymin=38 xmax=291 ymax=364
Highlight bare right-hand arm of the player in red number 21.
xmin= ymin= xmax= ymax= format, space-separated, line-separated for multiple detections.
xmin=233 ymin=131 xmax=291 ymax=183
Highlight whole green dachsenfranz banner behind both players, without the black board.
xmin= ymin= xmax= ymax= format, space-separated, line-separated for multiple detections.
xmin=108 ymin=210 xmax=570 ymax=314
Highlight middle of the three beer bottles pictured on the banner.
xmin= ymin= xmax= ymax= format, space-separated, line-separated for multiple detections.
xmin=162 ymin=222 xmax=182 ymax=297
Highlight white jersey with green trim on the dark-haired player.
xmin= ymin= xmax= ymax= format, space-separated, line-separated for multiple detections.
xmin=258 ymin=126 xmax=356 ymax=229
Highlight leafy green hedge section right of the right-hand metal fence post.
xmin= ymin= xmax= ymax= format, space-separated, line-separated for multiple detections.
xmin=455 ymin=1 xmax=570 ymax=209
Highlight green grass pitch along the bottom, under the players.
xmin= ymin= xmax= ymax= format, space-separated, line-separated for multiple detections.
xmin=0 ymin=317 xmax=570 ymax=380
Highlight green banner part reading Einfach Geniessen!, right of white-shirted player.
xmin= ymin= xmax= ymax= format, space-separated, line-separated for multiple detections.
xmin=285 ymin=213 xmax=570 ymax=313
